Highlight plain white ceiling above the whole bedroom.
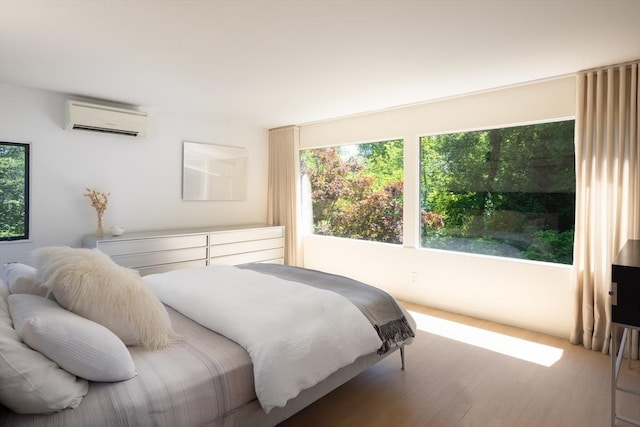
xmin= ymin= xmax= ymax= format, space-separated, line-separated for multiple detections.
xmin=0 ymin=0 xmax=640 ymax=128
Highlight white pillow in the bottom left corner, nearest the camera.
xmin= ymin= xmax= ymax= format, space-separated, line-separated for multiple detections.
xmin=0 ymin=298 xmax=89 ymax=414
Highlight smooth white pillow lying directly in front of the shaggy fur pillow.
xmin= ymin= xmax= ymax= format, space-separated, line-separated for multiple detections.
xmin=7 ymin=294 xmax=136 ymax=382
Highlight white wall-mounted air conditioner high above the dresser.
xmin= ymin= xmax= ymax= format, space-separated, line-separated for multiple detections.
xmin=66 ymin=100 xmax=147 ymax=138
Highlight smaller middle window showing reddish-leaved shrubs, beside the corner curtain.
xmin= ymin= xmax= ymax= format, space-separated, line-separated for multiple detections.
xmin=300 ymin=140 xmax=403 ymax=243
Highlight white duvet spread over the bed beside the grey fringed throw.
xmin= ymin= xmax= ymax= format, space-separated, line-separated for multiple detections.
xmin=143 ymin=266 xmax=381 ymax=413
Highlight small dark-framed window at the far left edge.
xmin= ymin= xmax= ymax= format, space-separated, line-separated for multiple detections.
xmin=0 ymin=141 xmax=29 ymax=241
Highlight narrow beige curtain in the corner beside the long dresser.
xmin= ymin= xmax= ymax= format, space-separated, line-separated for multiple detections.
xmin=267 ymin=126 xmax=303 ymax=266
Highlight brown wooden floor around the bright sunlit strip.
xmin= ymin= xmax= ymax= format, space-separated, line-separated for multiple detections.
xmin=280 ymin=304 xmax=640 ymax=427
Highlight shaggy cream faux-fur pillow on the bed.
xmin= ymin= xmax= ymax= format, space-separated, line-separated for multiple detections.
xmin=34 ymin=247 xmax=176 ymax=350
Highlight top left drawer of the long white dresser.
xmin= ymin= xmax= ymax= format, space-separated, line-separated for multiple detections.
xmin=98 ymin=234 xmax=209 ymax=257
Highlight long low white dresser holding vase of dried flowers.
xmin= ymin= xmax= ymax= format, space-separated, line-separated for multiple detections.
xmin=82 ymin=224 xmax=284 ymax=275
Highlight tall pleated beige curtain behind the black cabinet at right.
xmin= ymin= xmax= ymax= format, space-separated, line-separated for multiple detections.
xmin=571 ymin=62 xmax=640 ymax=358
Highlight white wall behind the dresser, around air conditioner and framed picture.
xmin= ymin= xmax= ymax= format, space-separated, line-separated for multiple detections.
xmin=0 ymin=84 xmax=268 ymax=263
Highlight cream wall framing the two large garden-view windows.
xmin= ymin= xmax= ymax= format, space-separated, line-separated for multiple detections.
xmin=300 ymin=76 xmax=575 ymax=337
